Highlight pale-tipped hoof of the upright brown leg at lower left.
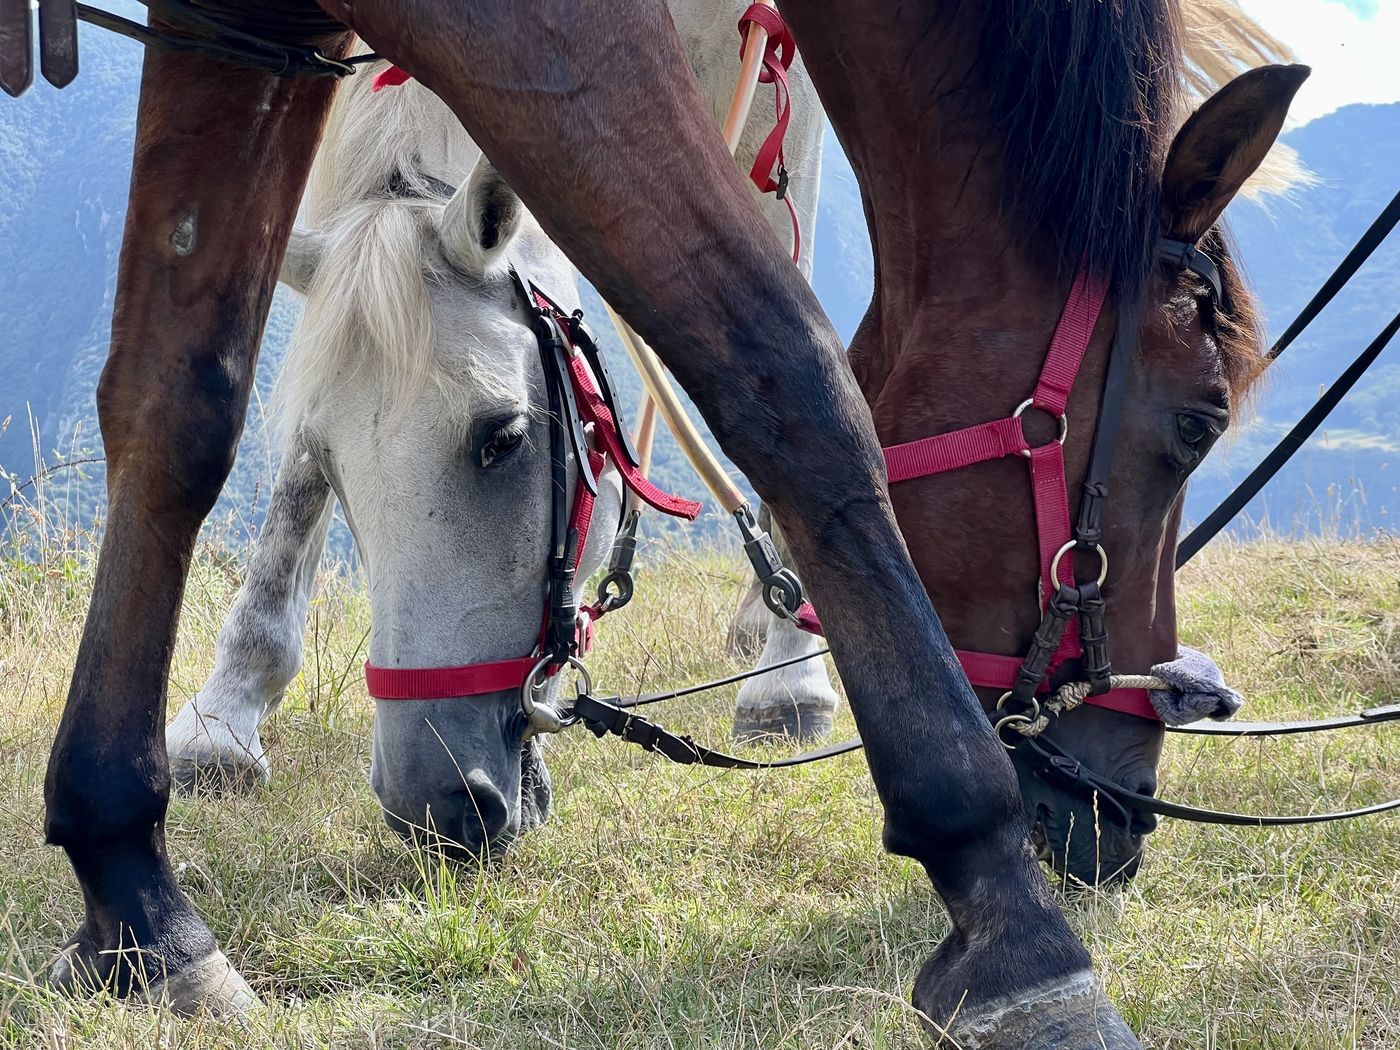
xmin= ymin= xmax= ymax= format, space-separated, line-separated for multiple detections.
xmin=49 ymin=938 xmax=260 ymax=1021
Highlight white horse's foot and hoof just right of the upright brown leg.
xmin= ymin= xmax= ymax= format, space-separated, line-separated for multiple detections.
xmin=165 ymin=697 xmax=272 ymax=795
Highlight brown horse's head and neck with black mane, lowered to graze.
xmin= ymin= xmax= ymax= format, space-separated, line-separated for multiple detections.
xmin=798 ymin=0 xmax=1308 ymax=883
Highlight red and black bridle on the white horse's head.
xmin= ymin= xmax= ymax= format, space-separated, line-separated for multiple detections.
xmin=364 ymin=267 xmax=700 ymax=700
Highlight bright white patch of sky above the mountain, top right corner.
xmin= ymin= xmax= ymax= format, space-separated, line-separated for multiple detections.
xmin=1240 ymin=0 xmax=1400 ymax=123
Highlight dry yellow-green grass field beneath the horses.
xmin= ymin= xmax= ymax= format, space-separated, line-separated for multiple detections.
xmin=0 ymin=529 xmax=1400 ymax=1050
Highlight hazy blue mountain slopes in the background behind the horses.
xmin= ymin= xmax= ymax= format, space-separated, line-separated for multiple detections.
xmin=0 ymin=20 xmax=1400 ymax=551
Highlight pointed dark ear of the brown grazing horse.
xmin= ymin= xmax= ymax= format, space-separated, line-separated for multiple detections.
xmin=1162 ymin=66 xmax=1312 ymax=242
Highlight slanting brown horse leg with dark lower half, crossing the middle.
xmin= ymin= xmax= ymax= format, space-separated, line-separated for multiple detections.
xmin=321 ymin=0 xmax=1133 ymax=1047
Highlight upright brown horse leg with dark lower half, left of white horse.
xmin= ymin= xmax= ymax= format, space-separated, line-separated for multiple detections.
xmin=45 ymin=32 xmax=352 ymax=1009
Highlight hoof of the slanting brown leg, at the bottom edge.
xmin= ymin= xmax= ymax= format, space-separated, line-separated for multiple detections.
xmin=914 ymin=973 xmax=1142 ymax=1050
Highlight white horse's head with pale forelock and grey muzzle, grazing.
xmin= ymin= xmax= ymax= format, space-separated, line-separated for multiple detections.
xmin=279 ymin=160 xmax=622 ymax=854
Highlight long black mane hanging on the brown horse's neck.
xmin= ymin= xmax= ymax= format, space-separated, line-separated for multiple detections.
xmin=949 ymin=0 xmax=1183 ymax=293
